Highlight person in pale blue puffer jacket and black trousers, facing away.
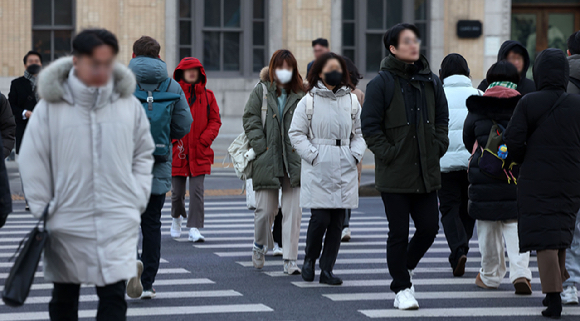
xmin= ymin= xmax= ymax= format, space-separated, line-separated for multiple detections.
xmin=438 ymin=53 xmax=482 ymax=276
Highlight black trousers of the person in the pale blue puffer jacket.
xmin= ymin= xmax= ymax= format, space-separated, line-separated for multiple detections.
xmin=438 ymin=171 xmax=475 ymax=268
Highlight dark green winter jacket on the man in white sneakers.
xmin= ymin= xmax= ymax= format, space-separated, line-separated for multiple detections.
xmin=361 ymin=55 xmax=449 ymax=193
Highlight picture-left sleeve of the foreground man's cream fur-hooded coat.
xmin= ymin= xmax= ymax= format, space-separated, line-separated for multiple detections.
xmin=18 ymin=100 xmax=54 ymax=217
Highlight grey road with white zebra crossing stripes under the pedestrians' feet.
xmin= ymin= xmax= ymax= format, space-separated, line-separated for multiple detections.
xmin=0 ymin=197 xmax=580 ymax=321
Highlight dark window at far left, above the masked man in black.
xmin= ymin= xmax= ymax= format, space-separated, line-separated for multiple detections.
xmin=32 ymin=0 xmax=74 ymax=63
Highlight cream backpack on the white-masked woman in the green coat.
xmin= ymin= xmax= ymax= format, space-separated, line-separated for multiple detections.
xmin=229 ymin=83 xmax=268 ymax=180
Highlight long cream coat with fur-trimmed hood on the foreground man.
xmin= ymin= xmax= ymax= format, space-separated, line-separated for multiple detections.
xmin=19 ymin=58 xmax=154 ymax=286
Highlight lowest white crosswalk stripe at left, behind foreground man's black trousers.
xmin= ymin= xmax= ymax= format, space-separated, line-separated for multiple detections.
xmin=0 ymin=304 xmax=274 ymax=321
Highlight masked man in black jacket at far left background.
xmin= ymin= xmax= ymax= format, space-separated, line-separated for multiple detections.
xmin=8 ymin=51 xmax=42 ymax=154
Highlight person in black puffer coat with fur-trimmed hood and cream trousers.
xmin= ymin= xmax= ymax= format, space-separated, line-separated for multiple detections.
xmin=463 ymin=60 xmax=532 ymax=294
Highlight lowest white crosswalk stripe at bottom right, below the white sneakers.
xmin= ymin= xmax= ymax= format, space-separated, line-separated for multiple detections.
xmin=359 ymin=306 xmax=580 ymax=318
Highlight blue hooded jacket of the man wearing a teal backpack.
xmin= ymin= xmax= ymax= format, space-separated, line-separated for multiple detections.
xmin=129 ymin=56 xmax=193 ymax=195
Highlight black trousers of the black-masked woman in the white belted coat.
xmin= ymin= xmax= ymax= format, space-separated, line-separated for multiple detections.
xmin=304 ymin=208 xmax=346 ymax=271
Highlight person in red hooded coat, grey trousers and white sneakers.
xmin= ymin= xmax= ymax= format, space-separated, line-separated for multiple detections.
xmin=171 ymin=57 xmax=222 ymax=242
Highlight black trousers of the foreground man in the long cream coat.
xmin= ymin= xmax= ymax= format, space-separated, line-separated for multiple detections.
xmin=48 ymin=281 xmax=127 ymax=321
